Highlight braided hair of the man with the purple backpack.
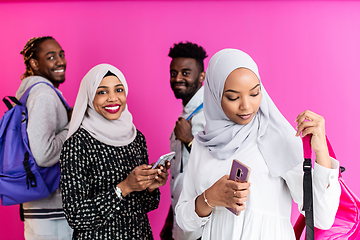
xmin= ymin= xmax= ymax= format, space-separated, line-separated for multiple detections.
xmin=20 ymin=36 xmax=55 ymax=80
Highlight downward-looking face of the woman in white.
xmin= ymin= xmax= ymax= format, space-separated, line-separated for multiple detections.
xmin=221 ymin=68 xmax=261 ymax=125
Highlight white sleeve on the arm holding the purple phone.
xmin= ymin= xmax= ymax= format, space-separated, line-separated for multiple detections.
xmin=175 ymin=141 xmax=212 ymax=232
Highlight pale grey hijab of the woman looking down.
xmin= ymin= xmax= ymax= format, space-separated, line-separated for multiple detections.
xmin=196 ymin=49 xmax=303 ymax=176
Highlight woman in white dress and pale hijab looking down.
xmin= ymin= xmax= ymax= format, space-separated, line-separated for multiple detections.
xmin=176 ymin=49 xmax=340 ymax=240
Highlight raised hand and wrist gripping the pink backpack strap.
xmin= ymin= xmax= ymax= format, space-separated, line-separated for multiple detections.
xmin=295 ymin=110 xmax=331 ymax=168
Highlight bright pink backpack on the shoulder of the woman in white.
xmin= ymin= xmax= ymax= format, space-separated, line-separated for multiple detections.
xmin=294 ymin=138 xmax=360 ymax=240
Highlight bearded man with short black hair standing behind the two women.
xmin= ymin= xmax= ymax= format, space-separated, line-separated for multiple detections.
xmin=160 ymin=42 xmax=207 ymax=240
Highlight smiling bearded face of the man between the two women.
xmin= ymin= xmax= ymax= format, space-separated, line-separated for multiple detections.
xmin=170 ymin=57 xmax=205 ymax=106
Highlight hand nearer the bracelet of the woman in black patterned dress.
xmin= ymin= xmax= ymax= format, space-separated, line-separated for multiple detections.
xmin=117 ymin=164 xmax=159 ymax=197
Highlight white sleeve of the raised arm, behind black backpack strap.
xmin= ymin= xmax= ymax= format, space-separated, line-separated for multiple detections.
xmin=282 ymin=158 xmax=341 ymax=229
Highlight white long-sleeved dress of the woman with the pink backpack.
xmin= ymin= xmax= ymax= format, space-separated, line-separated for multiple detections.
xmin=175 ymin=136 xmax=341 ymax=240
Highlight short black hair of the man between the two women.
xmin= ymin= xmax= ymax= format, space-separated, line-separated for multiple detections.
xmin=168 ymin=42 xmax=207 ymax=72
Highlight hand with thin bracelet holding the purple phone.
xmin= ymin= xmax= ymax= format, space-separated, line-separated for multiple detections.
xmin=195 ymin=175 xmax=251 ymax=217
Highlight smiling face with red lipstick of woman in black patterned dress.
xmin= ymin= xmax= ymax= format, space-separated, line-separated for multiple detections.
xmin=93 ymin=76 xmax=126 ymax=120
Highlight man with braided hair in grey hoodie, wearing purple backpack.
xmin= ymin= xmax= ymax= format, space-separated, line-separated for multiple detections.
xmin=16 ymin=37 xmax=72 ymax=240
